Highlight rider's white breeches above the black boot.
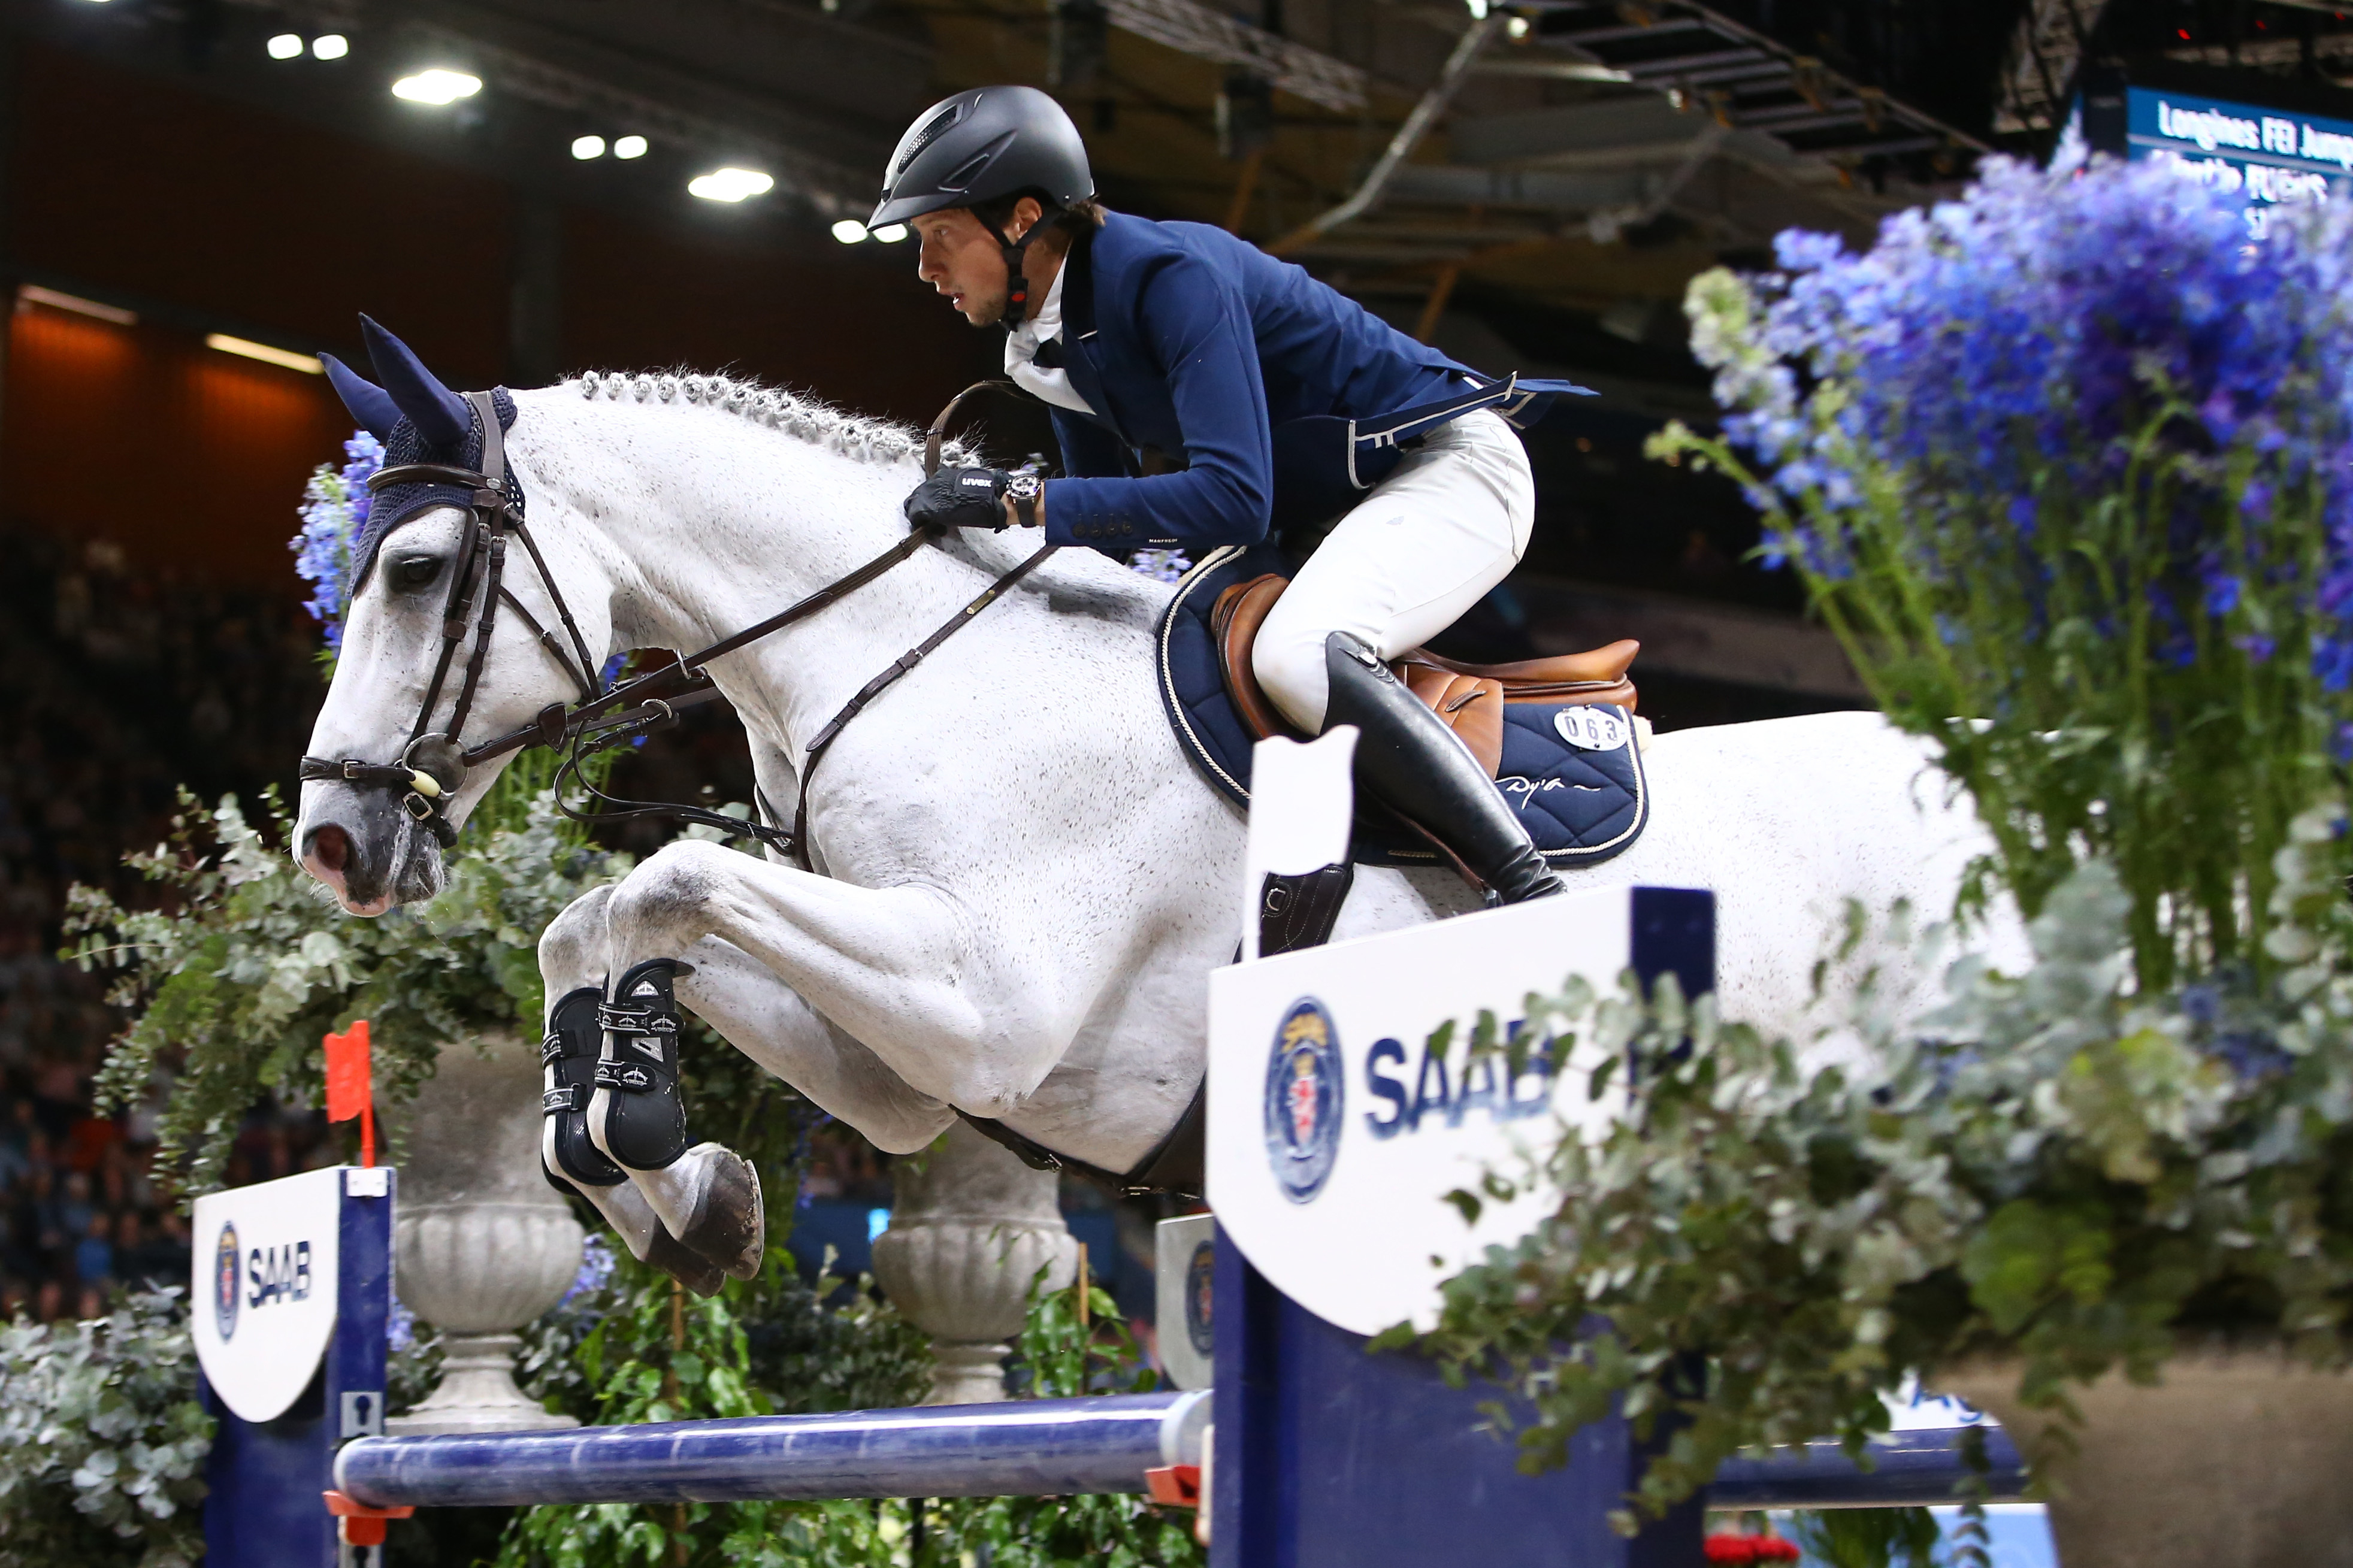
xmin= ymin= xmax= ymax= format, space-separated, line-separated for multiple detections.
xmin=1250 ymin=410 xmax=1537 ymax=734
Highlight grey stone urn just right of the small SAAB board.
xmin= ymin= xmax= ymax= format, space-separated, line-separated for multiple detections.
xmin=386 ymin=1034 xmax=581 ymax=1436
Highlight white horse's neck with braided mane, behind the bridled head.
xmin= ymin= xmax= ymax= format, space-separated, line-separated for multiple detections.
xmin=518 ymin=389 xmax=1148 ymax=758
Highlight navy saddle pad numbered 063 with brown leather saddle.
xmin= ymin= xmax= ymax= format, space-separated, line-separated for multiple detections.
xmin=1158 ymin=546 xmax=1650 ymax=871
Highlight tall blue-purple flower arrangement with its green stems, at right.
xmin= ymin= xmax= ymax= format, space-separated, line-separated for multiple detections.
xmin=1652 ymin=158 xmax=2353 ymax=984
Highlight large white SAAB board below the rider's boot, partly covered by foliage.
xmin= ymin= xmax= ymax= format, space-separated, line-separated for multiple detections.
xmin=1209 ymin=741 xmax=1633 ymax=1335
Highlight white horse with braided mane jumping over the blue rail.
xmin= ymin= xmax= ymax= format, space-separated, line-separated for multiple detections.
xmin=297 ymin=350 xmax=2024 ymax=1257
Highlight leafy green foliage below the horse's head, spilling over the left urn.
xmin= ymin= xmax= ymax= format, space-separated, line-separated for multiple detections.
xmin=66 ymin=779 xmax=631 ymax=1191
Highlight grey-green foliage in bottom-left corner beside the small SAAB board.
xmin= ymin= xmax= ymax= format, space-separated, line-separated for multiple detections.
xmin=0 ymin=1290 xmax=212 ymax=1568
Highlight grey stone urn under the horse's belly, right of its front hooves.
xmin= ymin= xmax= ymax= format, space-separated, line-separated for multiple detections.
xmin=875 ymin=1121 xmax=1078 ymax=1406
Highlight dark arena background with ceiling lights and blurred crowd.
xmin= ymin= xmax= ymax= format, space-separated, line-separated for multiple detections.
xmin=0 ymin=0 xmax=2353 ymax=1534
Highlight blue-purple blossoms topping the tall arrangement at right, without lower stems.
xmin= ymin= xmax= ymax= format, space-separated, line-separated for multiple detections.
xmin=1692 ymin=160 xmax=2353 ymax=690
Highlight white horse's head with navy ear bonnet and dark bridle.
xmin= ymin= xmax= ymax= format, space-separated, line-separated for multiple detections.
xmin=294 ymin=316 xmax=612 ymax=916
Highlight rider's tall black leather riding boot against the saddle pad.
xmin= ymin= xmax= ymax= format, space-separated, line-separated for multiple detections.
xmin=1324 ymin=631 xmax=1562 ymax=904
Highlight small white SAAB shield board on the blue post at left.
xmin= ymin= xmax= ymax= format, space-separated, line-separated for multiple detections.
xmin=188 ymin=1166 xmax=343 ymax=1422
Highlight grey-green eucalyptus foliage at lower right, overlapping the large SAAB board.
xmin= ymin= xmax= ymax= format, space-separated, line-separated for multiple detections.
xmin=1384 ymin=807 xmax=2353 ymax=1528
